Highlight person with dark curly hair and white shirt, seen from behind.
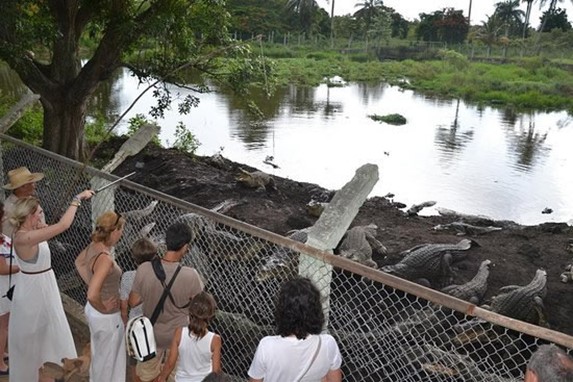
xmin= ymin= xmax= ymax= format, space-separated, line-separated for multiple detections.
xmin=249 ymin=277 xmax=342 ymax=382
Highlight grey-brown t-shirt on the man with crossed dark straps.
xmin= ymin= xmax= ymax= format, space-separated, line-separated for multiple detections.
xmin=131 ymin=262 xmax=204 ymax=349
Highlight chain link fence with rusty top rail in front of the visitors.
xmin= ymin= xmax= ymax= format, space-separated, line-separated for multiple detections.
xmin=0 ymin=135 xmax=573 ymax=382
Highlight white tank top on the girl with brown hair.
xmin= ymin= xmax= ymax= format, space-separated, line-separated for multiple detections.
xmin=175 ymin=327 xmax=215 ymax=382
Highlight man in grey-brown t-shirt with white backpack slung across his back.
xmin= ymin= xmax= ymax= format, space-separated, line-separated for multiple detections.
xmin=129 ymin=223 xmax=204 ymax=382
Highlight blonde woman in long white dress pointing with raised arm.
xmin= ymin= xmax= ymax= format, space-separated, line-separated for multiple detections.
xmin=8 ymin=190 xmax=94 ymax=382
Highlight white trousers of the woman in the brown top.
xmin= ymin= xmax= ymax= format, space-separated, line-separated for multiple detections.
xmin=85 ymin=302 xmax=126 ymax=382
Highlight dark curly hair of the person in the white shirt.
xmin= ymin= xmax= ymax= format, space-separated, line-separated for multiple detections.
xmin=275 ymin=277 xmax=324 ymax=339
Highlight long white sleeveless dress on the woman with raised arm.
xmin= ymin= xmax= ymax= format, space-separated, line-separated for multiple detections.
xmin=8 ymin=241 xmax=77 ymax=382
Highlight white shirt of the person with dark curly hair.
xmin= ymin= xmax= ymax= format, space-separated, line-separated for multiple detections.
xmin=249 ymin=334 xmax=342 ymax=382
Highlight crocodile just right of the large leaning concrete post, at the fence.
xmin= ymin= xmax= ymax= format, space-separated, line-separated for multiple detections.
xmin=338 ymin=224 xmax=388 ymax=268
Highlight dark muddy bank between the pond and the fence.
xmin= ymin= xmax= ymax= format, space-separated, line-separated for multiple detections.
xmin=100 ymin=141 xmax=573 ymax=335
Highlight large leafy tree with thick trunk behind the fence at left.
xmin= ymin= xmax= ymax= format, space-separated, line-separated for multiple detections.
xmin=0 ymin=0 xmax=239 ymax=159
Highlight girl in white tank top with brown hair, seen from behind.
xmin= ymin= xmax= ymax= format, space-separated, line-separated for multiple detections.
xmin=156 ymin=292 xmax=221 ymax=382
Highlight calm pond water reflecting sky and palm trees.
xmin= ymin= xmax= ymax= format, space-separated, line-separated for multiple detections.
xmin=0 ymin=66 xmax=573 ymax=224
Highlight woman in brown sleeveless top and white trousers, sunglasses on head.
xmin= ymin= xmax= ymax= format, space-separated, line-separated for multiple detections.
xmin=76 ymin=211 xmax=127 ymax=382
